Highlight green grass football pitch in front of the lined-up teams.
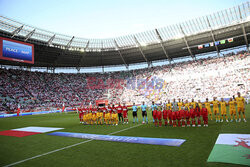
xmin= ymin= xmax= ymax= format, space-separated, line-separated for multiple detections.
xmin=0 ymin=105 xmax=250 ymax=167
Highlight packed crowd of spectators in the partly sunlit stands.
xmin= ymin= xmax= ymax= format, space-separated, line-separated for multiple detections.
xmin=0 ymin=49 xmax=250 ymax=111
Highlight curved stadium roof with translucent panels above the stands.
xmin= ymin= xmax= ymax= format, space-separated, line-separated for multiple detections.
xmin=0 ymin=2 xmax=250 ymax=67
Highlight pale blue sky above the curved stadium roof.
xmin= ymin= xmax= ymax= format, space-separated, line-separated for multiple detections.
xmin=0 ymin=0 xmax=246 ymax=38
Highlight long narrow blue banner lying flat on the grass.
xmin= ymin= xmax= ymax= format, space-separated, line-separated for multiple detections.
xmin=48 ymin=132 xmax=186 ymax=146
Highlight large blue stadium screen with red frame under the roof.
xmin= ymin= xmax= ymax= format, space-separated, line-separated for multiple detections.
xmin=0 ymin=37 xmax=34 ymax=64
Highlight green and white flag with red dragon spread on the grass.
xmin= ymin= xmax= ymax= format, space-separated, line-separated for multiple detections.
xmin=207 ymin=134 xmax=250 ymax=165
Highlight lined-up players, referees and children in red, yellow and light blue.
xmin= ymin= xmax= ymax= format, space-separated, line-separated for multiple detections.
xmin=77 ymin=92 xmax=246 ymax=127
